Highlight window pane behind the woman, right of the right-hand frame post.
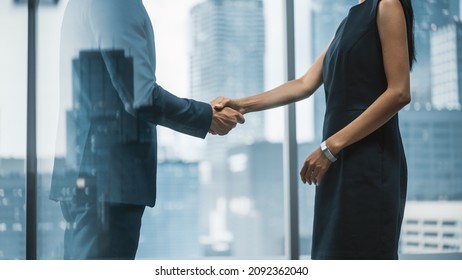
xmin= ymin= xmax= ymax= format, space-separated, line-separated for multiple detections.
xmin=296 ymin=0 xmax=462 ymax=259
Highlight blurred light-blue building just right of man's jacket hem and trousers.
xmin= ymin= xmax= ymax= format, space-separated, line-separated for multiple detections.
xmin=137 ymin=160 xmax=204 ymax=259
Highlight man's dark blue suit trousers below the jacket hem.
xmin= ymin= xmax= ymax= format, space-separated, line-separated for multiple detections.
xmin=60 ymin=198 xmax=145 ymax=260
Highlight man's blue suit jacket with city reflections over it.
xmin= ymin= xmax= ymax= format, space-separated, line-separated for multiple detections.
xmin=50 ymin=0 xmax=212 ymax=206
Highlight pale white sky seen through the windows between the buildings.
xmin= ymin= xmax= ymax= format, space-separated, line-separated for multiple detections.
xmin=0 ymin=0 xmax=313 ymax=158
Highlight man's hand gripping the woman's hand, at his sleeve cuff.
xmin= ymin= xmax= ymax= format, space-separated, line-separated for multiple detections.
xmin=209 ymin=104 xmax=245 ymax=135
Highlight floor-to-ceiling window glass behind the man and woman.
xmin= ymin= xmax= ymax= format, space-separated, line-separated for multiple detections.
xmin=0 ymin=0 xmax=462 ymax=259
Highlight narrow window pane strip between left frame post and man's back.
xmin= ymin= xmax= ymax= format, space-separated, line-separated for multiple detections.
xmin=37 ymin=0 xmax=67 ymax=259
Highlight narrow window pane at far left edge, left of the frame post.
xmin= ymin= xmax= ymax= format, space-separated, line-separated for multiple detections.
xmin=0 ymin=0 xmax=27 ymax=259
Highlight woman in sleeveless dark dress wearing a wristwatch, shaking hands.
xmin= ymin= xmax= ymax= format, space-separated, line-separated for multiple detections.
xmin=211 ymin=0 xmax=414 ymax=259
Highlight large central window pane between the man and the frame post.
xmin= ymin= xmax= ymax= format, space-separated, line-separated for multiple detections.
xmin=138 ymin=0 xmax=284 ymax=258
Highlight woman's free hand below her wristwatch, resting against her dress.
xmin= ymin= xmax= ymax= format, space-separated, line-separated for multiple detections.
xmin=300 ymin=148 xmax=331 ymax=185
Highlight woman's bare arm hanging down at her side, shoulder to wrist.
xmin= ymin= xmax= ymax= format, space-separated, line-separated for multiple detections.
xmin=327 ymin=0 xmax=411 ymax=154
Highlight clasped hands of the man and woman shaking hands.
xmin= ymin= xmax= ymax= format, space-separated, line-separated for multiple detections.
xmin=209 ymin=96 xmax=245 ymax=136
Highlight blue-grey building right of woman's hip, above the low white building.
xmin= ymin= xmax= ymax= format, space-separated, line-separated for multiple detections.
xmin=400 ymin=110 xmax=462 ymax=200
